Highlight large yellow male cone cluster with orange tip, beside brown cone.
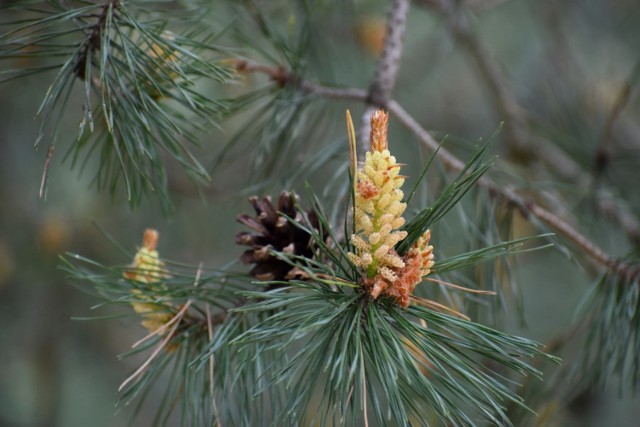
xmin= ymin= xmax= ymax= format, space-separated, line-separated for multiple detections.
xmin=349 ymin=110 xmax=434 ymax=307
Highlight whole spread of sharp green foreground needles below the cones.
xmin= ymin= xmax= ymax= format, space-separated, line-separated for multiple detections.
xmin=60 ymin=164 xmax=550 ymax=425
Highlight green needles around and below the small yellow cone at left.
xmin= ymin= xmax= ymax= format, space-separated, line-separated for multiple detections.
xmin=63 ymin=254 xmax=273 ymax=426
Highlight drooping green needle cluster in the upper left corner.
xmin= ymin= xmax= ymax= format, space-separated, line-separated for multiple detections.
xmin=0 ymin=0 xmax=233 ymax=211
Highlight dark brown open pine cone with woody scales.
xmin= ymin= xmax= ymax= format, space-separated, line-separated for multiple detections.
xmin=236 ymin=192 xmax=326 ymax=280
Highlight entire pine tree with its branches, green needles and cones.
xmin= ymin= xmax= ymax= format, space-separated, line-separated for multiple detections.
xmin=0 ymin=0 xmax=640 ymax=426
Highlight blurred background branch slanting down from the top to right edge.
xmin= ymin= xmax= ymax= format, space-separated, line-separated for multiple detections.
xmin=417 ymin=0 xmax=640 ymax=246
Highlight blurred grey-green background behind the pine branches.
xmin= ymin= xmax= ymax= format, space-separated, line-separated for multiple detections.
xmin=0 ymin=0 xmax=640 ymax=427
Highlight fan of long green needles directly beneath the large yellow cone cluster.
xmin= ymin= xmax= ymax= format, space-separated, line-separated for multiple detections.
xmin=236 ymin=282 xmax=543 ymax=425
